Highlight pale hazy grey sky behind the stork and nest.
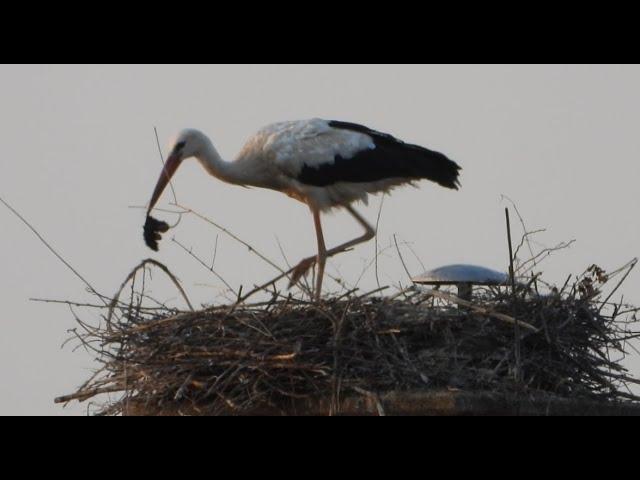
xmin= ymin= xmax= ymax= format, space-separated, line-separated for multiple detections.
xmin=0 ymin=65 xmax=640 ymax=415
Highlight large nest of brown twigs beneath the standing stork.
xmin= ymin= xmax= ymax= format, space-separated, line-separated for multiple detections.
xmin=58 ymin=260 xmax=640 ymax=415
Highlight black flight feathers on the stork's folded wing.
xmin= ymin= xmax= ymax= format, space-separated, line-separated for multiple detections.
xmin=298 ymin=121 xmax=460 ymax=190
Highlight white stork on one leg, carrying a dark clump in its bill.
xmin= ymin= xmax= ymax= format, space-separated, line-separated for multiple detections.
xmin=144 ymin=119 xmax=460 ymax=300
